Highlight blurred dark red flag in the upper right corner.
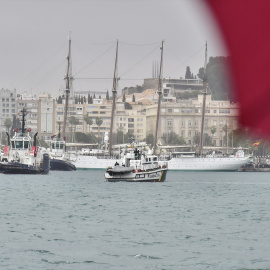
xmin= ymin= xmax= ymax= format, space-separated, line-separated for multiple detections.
xmin=205 ymin=0 xmax=270 ymax=138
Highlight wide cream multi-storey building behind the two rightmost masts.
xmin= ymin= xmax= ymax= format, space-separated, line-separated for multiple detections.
xmin=146 ymin=95 xmax=238 ymax=146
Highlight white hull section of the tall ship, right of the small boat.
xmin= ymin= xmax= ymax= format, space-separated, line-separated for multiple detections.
xmin=168 ymin=157 xmax=249 ymax=171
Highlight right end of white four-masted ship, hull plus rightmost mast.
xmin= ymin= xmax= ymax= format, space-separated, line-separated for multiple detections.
xmin=163 ymin=42 xmax=249 ymax=171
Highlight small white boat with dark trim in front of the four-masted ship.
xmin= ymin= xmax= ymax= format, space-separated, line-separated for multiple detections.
xmin=105 ymin=148 xmax=168 ymax=182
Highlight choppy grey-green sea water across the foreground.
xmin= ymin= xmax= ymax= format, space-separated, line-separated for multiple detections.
xmin=0 ymin=171 xmax=270 ymax=270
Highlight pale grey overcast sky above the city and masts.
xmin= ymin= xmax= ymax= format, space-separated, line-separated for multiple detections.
xmin=0 ymin=0 xmax=226 ymax=96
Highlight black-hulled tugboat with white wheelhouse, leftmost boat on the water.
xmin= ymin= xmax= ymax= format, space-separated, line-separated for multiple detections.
xmin=0 ymin=109 xmax=50 ymax=174
